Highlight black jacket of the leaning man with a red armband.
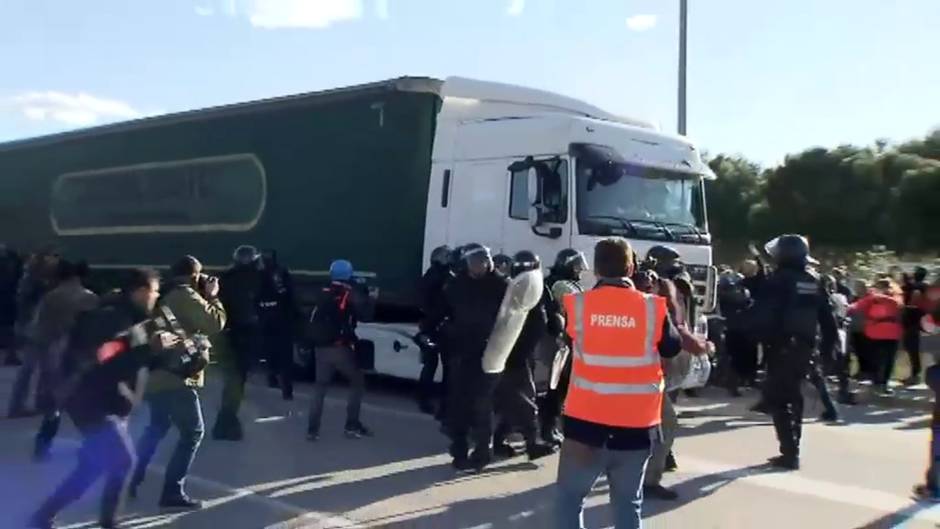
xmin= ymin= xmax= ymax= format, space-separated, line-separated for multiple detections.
xmin=65 ymin=297 xmax=156 ymax=424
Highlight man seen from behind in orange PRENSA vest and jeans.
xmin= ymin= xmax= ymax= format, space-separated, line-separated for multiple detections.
xmin=555 ymin=238 xmax=682 ymax=529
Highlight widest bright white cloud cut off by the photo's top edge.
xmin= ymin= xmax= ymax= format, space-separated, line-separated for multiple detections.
xmin=247 ymin=0 xmax=362 ymax=29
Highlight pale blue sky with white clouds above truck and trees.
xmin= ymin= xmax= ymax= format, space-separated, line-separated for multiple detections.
xmin=0 ymin=0 xmax=940 ymax=164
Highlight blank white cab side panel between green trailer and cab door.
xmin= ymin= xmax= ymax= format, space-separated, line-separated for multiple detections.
xmin=447 ymin=160 xmax=509 ymax=254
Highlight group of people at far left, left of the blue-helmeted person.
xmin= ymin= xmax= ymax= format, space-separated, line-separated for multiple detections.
xmin=0 ymin=246 xmax=306 ymax=528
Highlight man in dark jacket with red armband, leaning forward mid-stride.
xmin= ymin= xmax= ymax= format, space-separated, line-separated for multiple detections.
xmin=28 ymin=270 xmax=179 ymax=529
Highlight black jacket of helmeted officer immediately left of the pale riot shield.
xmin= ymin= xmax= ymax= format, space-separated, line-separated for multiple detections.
xmin=444 ymin=272 xmax=509 ymax=358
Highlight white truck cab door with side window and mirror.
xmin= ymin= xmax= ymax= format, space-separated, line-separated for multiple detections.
xmin=501 ymin=157 xmax=571 ymax=268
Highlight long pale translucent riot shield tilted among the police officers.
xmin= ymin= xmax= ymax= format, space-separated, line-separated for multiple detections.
xmin=483 ymin=270 xmax=544 ymax=373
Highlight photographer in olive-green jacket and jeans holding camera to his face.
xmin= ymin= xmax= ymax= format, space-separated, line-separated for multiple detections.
xmin=130 ymin=255 xmax=225 ymax=509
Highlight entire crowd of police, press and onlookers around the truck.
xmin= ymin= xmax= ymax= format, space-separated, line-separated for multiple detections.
xmin=0 ymin=235 xmax=940 ymax=528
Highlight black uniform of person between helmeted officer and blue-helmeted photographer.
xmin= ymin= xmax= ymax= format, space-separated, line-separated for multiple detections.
xmin=258 ymin=261 xmax=297 ymax=400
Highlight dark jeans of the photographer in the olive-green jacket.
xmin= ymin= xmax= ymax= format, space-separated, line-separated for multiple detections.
xmin=131 ymin=387 xmax=205 ymax=498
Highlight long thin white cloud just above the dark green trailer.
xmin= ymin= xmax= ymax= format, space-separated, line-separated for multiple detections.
xmin=4 ymin=91 xmax=148 ymax=127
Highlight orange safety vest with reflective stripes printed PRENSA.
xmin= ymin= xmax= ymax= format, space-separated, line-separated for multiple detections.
xmin=564 ymin=286 xmax=666 ymax=428
